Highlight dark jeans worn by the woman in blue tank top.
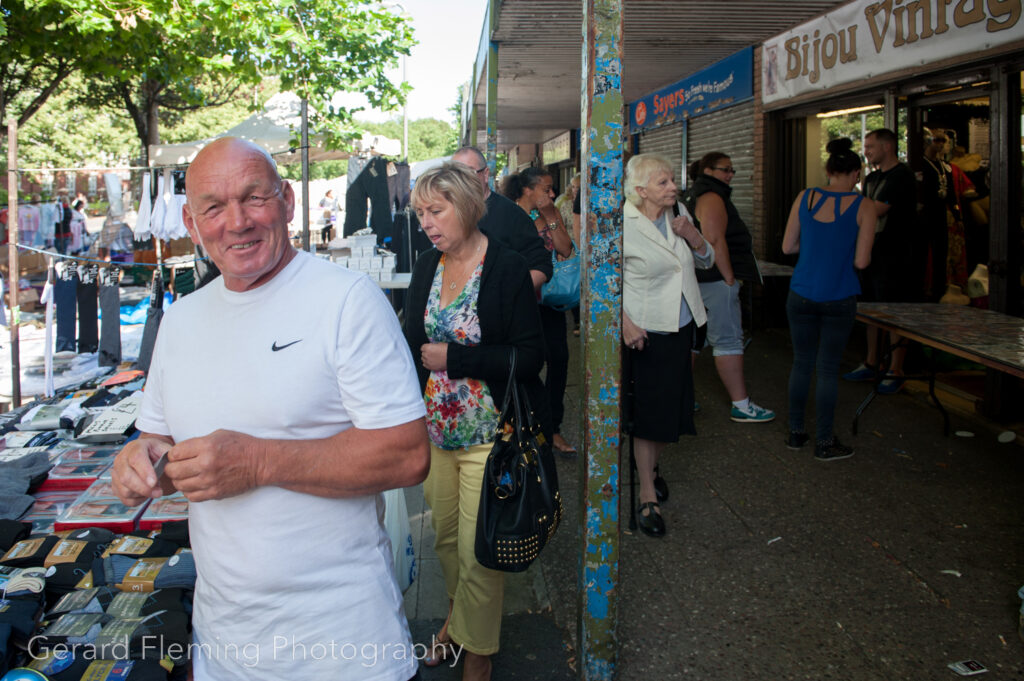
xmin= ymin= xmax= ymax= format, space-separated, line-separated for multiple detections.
xmin=785 ymin=291 xmax=857 ymax=440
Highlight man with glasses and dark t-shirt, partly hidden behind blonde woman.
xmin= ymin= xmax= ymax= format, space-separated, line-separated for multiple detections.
xmin=452 ymin=146 xmax=552 ymax=291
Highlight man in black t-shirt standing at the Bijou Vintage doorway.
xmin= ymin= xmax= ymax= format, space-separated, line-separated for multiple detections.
xmin=843 ymin=128 xmax=926 ymax=394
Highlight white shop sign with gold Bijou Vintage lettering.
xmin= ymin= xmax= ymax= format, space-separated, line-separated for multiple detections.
xmin=761 ymin=0 xmax=1024 ymax=104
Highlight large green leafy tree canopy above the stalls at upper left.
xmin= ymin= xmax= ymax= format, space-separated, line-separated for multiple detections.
xmin=12 ymin=0 xmax=413 ymax=160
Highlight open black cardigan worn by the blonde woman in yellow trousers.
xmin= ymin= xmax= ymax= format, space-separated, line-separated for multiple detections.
xmin=403 ymin=239 xmax=551 ymax=438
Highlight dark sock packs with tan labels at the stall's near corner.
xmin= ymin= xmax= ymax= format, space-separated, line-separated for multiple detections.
xmin=0 ymin=522 xmax=196 ymax=681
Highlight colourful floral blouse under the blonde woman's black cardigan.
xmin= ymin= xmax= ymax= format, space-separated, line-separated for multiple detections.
xmin=423 ymin=257 xmax=499 ymax=450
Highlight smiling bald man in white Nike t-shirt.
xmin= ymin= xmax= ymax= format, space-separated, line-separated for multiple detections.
xmin=114 ymin=138 xmax=429 ymax=681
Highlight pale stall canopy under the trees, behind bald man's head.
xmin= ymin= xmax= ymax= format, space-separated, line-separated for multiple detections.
xmin=150 ymin=92 xmax=401 ymax=166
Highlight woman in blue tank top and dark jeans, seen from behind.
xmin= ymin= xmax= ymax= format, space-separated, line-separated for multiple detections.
xmin=782 ymin=138 xmax=878 ymax=461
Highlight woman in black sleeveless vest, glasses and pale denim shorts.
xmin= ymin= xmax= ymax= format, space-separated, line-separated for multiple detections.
xmin=686 ymin=152 xmax=775 ymax=423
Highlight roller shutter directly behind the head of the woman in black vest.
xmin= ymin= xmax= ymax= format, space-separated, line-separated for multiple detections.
xmin=686 ymin=99 xmax=754 ymax=225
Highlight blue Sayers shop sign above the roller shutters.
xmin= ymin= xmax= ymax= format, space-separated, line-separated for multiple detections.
xmin=630 ymin=47 xmax=754 ymax=134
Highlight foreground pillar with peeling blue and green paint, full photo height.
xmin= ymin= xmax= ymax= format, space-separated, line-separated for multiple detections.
xmin=578 ymin=0 xmax=623 ymax=681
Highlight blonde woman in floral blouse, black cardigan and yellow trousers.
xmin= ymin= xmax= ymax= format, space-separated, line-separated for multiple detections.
xmin=404 ymin=163 xmax=551 ymax=680
